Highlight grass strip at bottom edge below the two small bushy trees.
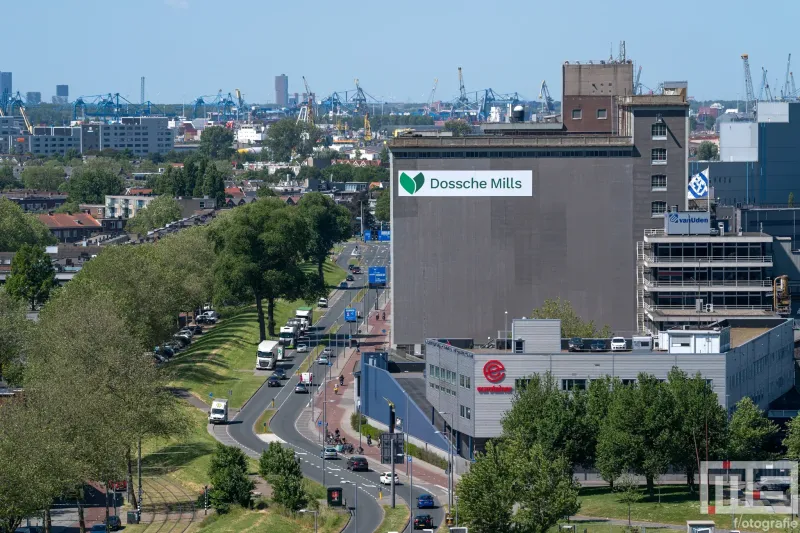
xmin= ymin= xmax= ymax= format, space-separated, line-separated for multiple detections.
xmin=195 ymin=507 xmax=347 ymax=533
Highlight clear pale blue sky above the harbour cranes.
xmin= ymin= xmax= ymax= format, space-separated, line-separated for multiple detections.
xmin=0 ymin=0 xmax=800 ymax=102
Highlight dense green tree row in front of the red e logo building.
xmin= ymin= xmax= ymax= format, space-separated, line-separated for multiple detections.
xmin=457 ymin=368 xmax=800 ymax=533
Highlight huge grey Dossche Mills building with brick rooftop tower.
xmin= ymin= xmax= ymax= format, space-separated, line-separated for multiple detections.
xmin=389 ymin=60 xmax=689 ymax=352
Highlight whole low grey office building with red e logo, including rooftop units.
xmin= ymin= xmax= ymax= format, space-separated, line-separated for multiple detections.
xmin=425 ymin=317 xmax=794 ymax=458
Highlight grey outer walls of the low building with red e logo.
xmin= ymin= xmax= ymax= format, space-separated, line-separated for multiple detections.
xmin=425 ymin=318 xmax=794 ymax=456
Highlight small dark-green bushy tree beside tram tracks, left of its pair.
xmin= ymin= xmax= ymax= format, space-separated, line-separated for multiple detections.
xmin=208 ymin=443 xmax=255 ymax=514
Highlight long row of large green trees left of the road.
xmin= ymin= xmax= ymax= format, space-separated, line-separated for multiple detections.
xmin=0 ymin=193 xmax=350 ymax=533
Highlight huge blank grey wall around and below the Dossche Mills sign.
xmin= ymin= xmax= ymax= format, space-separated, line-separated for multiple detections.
xmin=392 ymin=154 xmax=636 ymax=344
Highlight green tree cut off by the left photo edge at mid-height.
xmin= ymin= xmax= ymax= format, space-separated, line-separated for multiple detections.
xmin=0 ymin=287 xmax=33 ymax=385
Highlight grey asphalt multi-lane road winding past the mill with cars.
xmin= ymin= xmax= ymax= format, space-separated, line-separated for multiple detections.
xmin=227 ymin=244 xmax=444 ymax=533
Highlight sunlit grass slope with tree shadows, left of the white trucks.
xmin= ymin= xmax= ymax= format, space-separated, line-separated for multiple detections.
xmin=169 ymin=262 xmax=346 ymax=408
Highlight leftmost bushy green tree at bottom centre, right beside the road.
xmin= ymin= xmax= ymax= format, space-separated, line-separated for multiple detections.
xmin=456 ymin=441 xmax=517 ymax=533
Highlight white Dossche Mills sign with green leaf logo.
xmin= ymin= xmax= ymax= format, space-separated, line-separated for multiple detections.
xmin=397 ymin=170 xmax=533 ymax=197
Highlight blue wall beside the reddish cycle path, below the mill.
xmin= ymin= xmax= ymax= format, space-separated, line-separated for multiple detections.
xmin=360 ymin=365 xmax=447 ymax=451
